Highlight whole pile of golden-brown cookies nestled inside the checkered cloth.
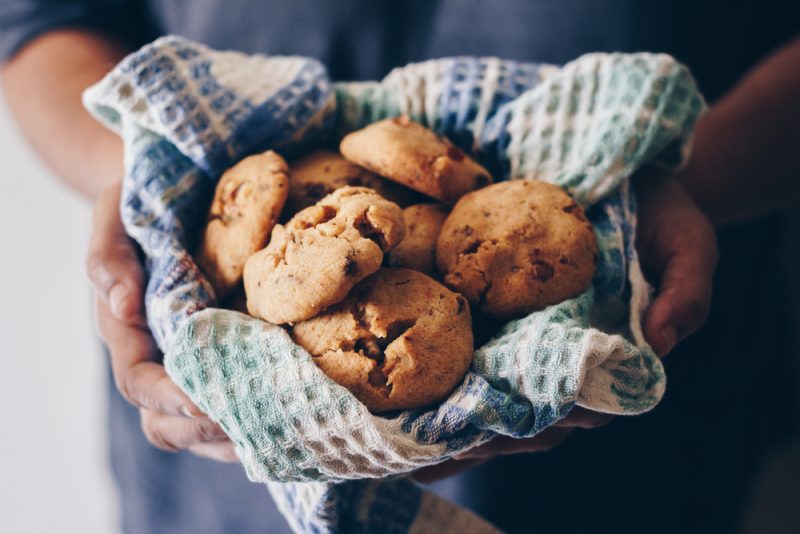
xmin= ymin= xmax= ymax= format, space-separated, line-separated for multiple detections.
xmin=196 ymin=117 xmax=597 ymax=413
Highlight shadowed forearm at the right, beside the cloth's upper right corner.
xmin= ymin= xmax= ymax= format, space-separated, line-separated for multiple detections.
xmin=679 ymin=39 xmax=800 ymax=224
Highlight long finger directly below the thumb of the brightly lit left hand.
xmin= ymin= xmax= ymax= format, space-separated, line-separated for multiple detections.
xmin=96 ymin=298 xmax=203 ymax=416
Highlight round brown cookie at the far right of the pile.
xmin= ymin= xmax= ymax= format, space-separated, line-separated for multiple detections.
xmin=436 ymin=180 xmax=597 ymax=319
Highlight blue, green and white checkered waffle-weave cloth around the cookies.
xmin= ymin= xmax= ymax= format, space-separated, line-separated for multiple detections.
xmin=85 ymin=37 xmax=704 ymax=532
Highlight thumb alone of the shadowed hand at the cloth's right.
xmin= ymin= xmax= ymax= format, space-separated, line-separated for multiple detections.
xmin=644 ymin=217 xmax=719 ymax=356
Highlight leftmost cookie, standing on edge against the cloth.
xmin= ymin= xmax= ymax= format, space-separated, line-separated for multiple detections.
xmin=196 ymin=150 xmax=289 ymax=300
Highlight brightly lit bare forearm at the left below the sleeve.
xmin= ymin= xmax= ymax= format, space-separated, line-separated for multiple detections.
xmin=0 ymin=31 xmax=125 ymax=203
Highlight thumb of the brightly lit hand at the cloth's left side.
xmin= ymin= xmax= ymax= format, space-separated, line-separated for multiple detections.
xmin=86 ymin=184 xmax=144 ymax=324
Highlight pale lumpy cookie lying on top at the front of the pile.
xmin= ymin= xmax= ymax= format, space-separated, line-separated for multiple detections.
xmin=244 ymin=187 xmax=406 ymax=324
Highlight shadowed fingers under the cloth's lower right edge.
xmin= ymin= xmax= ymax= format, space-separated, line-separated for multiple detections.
xmin=412 ymin=406 xmax=613 ymax=484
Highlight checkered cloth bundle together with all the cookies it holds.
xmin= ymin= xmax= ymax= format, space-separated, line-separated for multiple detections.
xmin=85 ymin=37 xmax=704 ymax=532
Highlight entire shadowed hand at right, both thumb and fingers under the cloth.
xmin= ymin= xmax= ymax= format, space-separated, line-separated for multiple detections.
xmin=412 ymin=172 xmax=718 ymax=483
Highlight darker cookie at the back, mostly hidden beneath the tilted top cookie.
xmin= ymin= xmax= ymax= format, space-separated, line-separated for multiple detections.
xmin=285 ymin=150 xmax=416 ymax=216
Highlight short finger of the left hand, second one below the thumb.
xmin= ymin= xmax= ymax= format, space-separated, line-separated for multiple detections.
xmin=139 ymin=409 xmax=228 ymax=452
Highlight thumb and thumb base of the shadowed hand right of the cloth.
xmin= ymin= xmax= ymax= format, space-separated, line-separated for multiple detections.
xmin=635 ymin=173 xmax=719 ymax=356
